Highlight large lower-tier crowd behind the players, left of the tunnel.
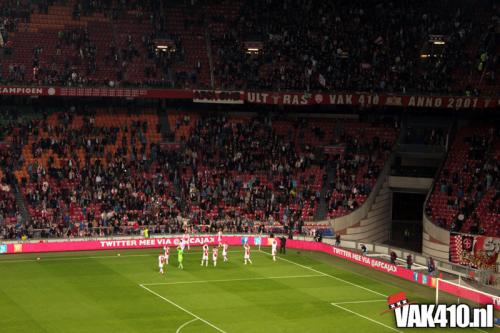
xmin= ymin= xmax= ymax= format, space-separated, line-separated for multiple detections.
xmin=0 ymin=113 xmax=398 ymax=238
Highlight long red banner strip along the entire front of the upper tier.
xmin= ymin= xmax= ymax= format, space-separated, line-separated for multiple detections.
xmin=0 ymin=86 xmax=500 ymax=109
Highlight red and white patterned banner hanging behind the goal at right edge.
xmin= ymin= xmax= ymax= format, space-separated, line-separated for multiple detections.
xmin=450 ymin=233 xmax=500 ymax=269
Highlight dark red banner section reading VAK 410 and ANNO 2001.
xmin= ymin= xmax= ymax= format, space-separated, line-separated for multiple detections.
xmin=245 ymin=91 xmax=500 ymax=109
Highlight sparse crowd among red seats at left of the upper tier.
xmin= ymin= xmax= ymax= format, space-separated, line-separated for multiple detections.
xmin=0 ymin=0 xmax=196 ymax=87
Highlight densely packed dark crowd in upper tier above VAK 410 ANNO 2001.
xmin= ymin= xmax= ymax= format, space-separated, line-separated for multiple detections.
xmin=212 ymin=0 xmax=498 ymax=93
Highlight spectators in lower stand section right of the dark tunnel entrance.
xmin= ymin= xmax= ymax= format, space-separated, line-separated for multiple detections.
xmin=426 ymin=126 xmax=500 ymax=237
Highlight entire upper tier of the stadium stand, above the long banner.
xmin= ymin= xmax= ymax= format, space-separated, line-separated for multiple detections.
xmin=0 ymin=0 xmax=499 ymax=95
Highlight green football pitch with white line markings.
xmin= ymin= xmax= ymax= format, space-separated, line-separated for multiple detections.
xmin=0 ymin=247 xmax=498 ymax=333
